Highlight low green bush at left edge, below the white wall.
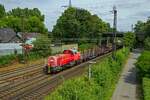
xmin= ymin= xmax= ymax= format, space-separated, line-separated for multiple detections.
xmin=0 ymin=55 xmax=16 ymax=67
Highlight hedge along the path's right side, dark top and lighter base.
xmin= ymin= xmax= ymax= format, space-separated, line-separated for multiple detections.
xmin=136 ymin=50 xmax=150 ymax=100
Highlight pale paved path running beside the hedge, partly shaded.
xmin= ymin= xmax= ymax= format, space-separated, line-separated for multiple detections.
xmin=112 ymin=50 xmax=140 ymax=100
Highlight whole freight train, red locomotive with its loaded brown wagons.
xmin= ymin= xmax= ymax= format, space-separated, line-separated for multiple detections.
xmin=44 ymin=46 xmax=112 ymax=74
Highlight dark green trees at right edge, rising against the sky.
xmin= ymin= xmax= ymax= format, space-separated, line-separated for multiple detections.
xmin=134 ymin=18 xmax=150 ymax=50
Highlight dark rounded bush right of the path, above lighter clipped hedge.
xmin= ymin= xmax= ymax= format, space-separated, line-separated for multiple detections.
xmin=136 ymin=51 xmax=150 ymax=77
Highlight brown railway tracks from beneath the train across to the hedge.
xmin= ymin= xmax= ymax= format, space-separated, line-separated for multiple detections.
xmin=0 ymin=53 xmax=110 ymax=100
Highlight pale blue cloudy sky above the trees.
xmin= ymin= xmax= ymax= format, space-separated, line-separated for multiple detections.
xmin=0 ymin=0 xmax=150 ymax=31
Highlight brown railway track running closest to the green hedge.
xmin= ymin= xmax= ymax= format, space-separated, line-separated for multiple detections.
xmin=14 ymin=60 xmax=85 ymax=100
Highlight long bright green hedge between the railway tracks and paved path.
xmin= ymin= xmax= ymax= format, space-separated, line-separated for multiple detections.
xmin=45 ymin=48 xmax=129 ymax=100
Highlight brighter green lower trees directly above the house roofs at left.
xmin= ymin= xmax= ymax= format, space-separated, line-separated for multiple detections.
xmin=0 ymin=16 xmax=48 ymax=33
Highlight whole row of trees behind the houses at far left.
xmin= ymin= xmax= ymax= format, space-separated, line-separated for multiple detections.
xmin=0 ymin=4 xmax=48 ymax=33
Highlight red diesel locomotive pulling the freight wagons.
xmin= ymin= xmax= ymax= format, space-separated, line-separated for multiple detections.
xmin=45 ymin=49 xmax=81 ymax=73
